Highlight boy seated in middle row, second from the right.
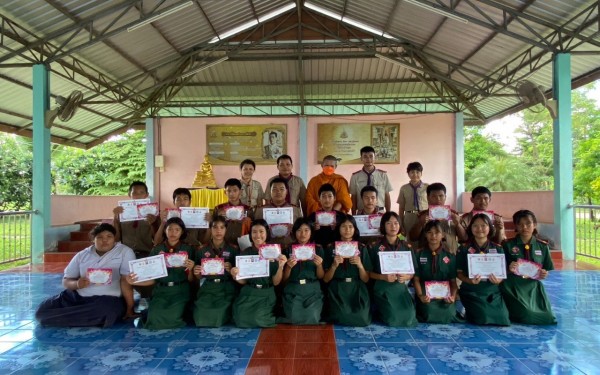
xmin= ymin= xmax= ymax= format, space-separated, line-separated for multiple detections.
xmin=409 ymin=182 xmax=467 ymax=254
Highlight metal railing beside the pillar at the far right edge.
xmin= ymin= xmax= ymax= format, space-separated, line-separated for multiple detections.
xmin=573 ymin=205 xmax=600 ymax=259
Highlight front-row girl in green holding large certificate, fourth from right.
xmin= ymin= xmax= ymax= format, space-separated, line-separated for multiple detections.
xmin=369 ymin=211 xmax=417 ymax=327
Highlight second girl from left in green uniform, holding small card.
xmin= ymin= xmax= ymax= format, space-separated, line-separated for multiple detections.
xmin=194 ymin=216 xmax=237 ymax=327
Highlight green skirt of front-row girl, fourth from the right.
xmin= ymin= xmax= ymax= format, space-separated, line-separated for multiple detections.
xmin=373 ymin=280 xmax=417 ymax=327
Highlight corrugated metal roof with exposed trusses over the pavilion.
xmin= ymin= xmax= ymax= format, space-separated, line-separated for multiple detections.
xmin=0 ymin=0 xmax=600 ymax=148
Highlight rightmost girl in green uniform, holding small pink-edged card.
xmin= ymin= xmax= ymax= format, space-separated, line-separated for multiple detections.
xmin=500 ymin=210 xmax=556 ymax=325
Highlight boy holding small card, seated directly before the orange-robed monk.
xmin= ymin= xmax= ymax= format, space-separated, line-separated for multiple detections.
xmin=308 ymin=184 xmax=346 ymax=248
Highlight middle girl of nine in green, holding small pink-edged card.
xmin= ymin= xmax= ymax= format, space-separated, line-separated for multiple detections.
xmin=323 ymin=216 xmax=371 ymax=327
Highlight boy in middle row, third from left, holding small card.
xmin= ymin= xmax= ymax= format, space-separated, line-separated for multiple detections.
xmin=213 ymin=178 xmax=254 ymax=246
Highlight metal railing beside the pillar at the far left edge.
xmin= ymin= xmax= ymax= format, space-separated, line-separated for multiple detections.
xmin=0 ymin=211 xmax=34 ymax=264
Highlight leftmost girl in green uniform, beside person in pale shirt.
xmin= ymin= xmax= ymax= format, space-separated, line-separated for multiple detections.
xmin=127 ymin=217 xmax=194 ymax=329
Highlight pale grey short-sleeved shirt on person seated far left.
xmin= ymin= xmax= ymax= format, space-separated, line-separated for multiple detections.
xmin=64 ymin=243 xmax=135 ymax=297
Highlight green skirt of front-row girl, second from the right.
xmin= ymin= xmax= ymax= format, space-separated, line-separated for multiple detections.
xmin=458 ymin=282 xmax=510 ymax=326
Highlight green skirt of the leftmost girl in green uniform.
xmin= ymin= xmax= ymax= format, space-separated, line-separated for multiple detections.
xmin=144 ymin=281 xmax=190 ymax=329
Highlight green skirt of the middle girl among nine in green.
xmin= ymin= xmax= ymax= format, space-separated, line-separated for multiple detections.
xmin=327 ymin=279 xmax=371 ymax=327
